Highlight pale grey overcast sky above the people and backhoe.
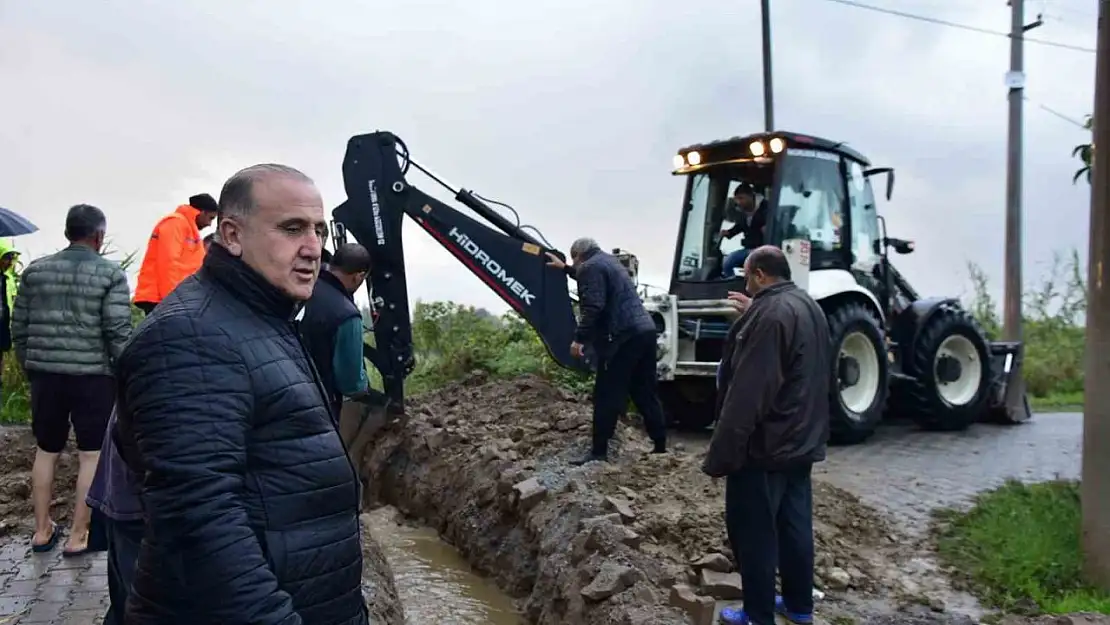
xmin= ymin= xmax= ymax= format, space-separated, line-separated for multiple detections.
xmin=0 ymin=0 xmax=1097 ymax=311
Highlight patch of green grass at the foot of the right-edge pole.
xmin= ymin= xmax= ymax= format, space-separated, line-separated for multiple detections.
xmin=937 ymin=481 xmax=1110 ymax=614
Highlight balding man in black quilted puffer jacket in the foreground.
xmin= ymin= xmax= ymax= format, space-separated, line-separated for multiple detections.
xmin=113 ymin=165 xmax=367 ymax=625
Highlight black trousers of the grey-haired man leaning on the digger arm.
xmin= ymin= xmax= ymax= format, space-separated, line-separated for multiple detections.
xmin=591 ymin=330 xmax=667 ymax=456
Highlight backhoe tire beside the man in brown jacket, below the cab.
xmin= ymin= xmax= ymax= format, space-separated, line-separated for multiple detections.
xmin=827 ymin=302 xmax=890 ymax=445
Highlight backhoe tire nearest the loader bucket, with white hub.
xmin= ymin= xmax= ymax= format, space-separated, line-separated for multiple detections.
xmin=894 ymin=304 xmax=990 ymax=432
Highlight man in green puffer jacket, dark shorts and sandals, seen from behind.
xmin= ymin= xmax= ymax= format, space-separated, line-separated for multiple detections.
xmin=11 ymin=204 xmax=131 ymax=556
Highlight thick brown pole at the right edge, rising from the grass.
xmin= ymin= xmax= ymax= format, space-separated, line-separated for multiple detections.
xmin=1080 ymin=0 xmax=1110 ymax=591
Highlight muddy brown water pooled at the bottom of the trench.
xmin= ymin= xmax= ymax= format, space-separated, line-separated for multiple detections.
xmin=369 ymin=507 xmax=525 ymax=625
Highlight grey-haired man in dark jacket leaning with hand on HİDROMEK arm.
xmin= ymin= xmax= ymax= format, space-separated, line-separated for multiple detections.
xmin=547 ymin=239 xmax=667 ymax=465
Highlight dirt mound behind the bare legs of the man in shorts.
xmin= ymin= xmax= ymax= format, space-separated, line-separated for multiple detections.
xmin=0 ymin=426 xmax=77 ymax=536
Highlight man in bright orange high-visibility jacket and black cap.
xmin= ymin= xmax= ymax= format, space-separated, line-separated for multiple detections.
xmin=134 ymin=193 xmax=219 ymax=314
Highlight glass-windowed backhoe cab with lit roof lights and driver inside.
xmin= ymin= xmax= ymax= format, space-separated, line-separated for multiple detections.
xmin=670 ymin=132 xmax=894 ymax=300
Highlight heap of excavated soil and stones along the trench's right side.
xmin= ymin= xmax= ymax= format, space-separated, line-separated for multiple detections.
xmin=363 ymin=374 xmax=954 ymax=625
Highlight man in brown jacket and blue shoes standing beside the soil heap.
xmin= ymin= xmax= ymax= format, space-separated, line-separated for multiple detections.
xmin=702 ymin=245 xmax=831 ymax=625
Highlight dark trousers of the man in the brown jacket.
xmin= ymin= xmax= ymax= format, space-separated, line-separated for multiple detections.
xmin=725 ymin=464 xmax=814 ymax=625
